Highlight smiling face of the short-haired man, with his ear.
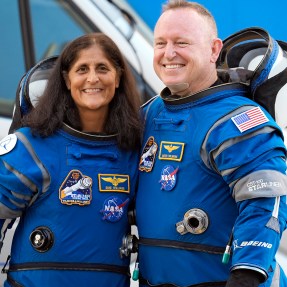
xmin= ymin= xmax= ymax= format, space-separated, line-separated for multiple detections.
xmin=153 ymin=8 xmax=222 ymax=95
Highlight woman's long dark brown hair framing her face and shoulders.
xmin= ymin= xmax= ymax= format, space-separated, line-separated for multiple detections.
xmin=22 ymin=33 xmax=142 ymax=149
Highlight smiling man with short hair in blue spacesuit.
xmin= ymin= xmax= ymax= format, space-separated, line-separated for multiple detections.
xmin=136 ymin=0 xmax=287 ymax=287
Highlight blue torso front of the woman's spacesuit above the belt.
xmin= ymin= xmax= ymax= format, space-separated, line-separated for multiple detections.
xmin=11 ymin=128 xmax=138 ymax=266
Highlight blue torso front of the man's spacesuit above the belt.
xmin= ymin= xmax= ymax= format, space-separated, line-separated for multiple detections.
xmin=137 ymin=98 xmax=240 ymax=246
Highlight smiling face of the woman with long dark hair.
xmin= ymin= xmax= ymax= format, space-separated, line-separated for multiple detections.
xmin=64 ymin=44 xmax=119 ymax=119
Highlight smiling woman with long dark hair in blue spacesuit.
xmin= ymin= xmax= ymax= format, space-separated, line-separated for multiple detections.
xmin=0 ymin=33 xmax=141 ymax=287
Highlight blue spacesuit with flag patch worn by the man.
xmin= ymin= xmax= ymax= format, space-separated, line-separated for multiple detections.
xmin=136 ymin=82 xmax=287 ymax=287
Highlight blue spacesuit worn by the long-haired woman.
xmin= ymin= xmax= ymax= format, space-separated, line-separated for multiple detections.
xmin=0 ymin=125 xmax=138 ymax=287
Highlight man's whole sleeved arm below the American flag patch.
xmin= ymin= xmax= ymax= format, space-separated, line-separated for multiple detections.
xmin=207 ymin=118 xmax=287 ymax=287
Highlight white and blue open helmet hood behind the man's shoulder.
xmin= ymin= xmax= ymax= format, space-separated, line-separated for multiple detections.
xmin=217 ymin=27 xmax=287 ymax=129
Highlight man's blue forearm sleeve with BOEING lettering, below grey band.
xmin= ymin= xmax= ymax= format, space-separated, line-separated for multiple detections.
xmin=232 ymin=196 xmax=287 ymax=278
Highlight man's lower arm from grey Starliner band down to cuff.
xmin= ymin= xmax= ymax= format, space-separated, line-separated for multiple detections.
xmin=231 ymin=165 xmax=287 ymax=279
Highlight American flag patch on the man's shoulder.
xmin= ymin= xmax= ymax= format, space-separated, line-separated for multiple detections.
xmin=231 ymin=107 xmax=269 ymax=132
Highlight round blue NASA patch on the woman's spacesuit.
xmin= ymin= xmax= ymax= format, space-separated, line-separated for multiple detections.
xmin=101 ymin=196 xmax=129 ymax=222
